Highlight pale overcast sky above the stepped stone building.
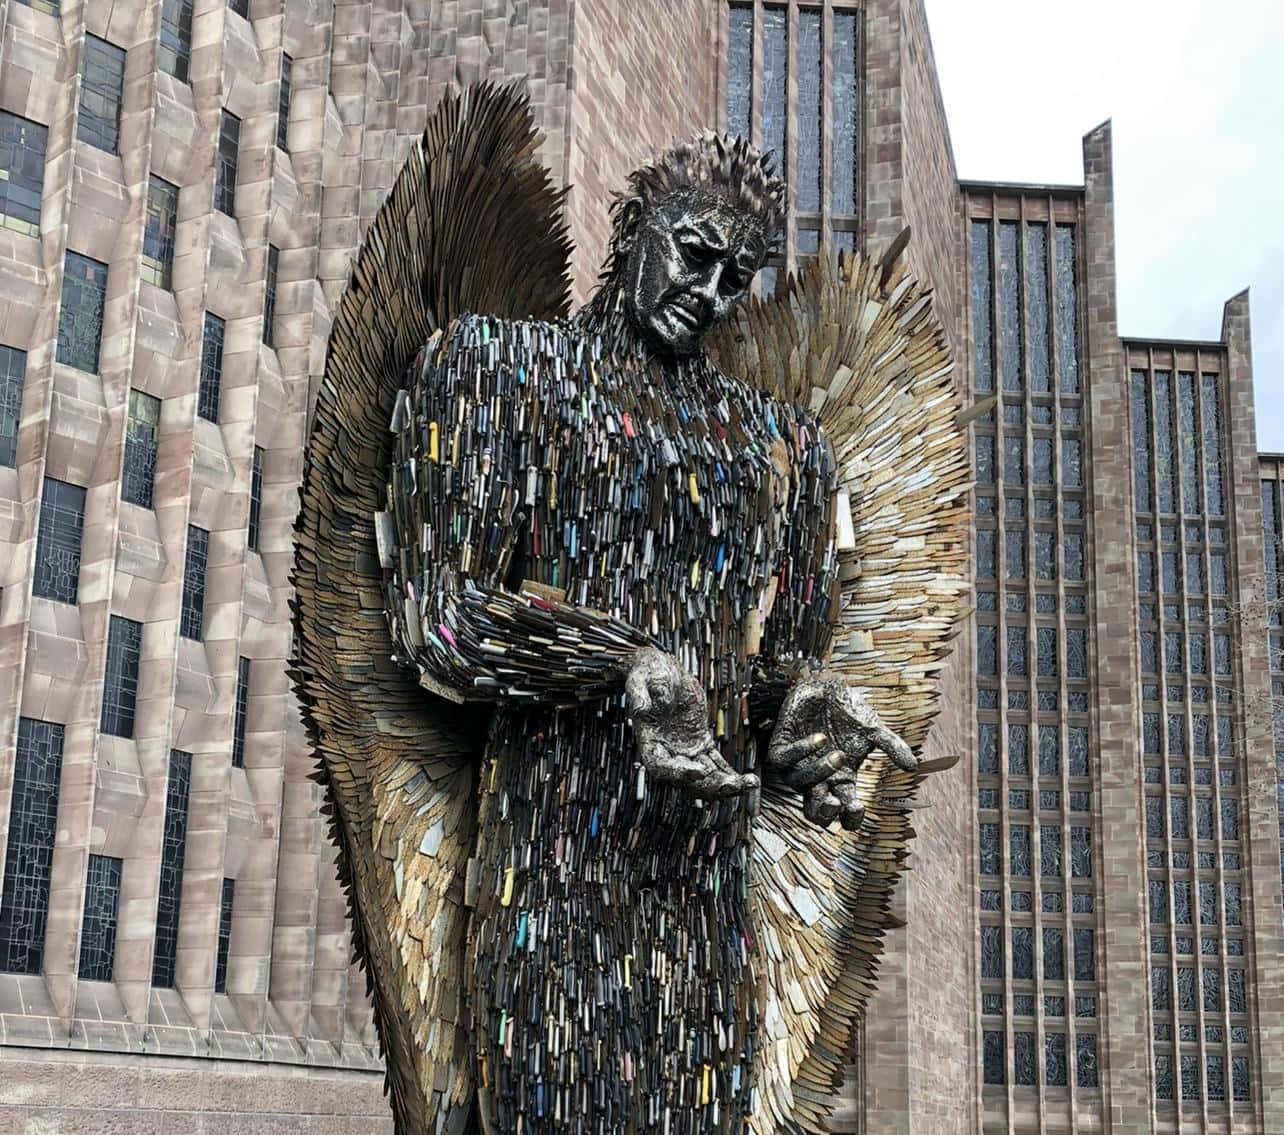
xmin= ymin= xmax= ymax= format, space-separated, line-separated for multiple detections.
xmin=927 ymin=0 xmax=1284 ymax=452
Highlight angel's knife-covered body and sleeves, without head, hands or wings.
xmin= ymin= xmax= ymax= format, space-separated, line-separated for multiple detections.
xmin=383 ymin=316 xmax=837 ymax=1135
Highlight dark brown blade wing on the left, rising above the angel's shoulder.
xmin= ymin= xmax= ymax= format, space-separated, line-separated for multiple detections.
xmin=293 ymin=85 xmax=570 ymax=1135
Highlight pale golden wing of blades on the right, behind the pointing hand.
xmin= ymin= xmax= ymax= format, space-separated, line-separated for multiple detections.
xmin=710 ymin=240 xmax=968 ymax=1135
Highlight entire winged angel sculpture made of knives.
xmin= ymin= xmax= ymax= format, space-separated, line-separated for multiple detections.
xmin=294 ymin=86 xmax=967 ymax=1135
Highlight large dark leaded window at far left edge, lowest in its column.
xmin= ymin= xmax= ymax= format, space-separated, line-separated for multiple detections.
xmin=0 ymin=718 xmax=63 ymax=973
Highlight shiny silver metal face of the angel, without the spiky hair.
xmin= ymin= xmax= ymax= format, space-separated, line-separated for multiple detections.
xmin=621 ymin=193 xmax=767 ymax=357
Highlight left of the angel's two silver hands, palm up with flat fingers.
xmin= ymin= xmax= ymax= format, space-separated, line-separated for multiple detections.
xmin=624 ymin=647 xmax=759 ymax=800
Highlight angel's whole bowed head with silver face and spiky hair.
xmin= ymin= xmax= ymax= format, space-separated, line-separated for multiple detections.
xmin=602 ymin=134 xmax=785 ymax=357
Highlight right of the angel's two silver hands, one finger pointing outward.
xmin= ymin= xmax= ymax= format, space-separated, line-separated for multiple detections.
xmin=767 ymin=677 xmax=918 ymax=831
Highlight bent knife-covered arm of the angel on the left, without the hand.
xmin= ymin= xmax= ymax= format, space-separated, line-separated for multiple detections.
xmin=380 ymin=317 xmax=650 ymax=701
